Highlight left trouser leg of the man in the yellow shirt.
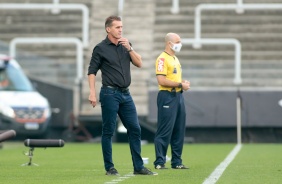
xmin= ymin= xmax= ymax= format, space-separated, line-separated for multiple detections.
xmin=154 ymin=91 xmax=176 ymax=166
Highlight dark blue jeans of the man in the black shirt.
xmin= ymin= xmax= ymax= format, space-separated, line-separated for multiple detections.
xmin=100 ymin=87 xmax=144 ymax=171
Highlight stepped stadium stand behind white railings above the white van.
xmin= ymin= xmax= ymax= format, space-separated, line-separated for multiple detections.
xmin=0 ymin=0 xmax=92 ymax=87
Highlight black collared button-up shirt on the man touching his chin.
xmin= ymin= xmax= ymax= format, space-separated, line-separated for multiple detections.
xmin=88 ymin=37 xmax=132 ymax=88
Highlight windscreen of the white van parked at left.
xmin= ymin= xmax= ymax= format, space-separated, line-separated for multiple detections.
xmin=0 ymin=64 xmax=34 ymax=91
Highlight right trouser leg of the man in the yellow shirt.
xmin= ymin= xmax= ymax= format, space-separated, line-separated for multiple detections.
xmin=170 ymin=93 xmax=186 ymax=167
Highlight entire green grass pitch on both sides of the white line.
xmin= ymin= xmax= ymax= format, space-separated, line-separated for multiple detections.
xmin=0 ymin=141 xmax=282 ymax=184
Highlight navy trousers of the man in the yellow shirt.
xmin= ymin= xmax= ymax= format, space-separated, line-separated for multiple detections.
xmin=154 ymin=91 xmax=186 ymax=167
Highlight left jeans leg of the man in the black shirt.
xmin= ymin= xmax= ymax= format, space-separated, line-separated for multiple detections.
xmin=100 ymin=88 xmax=119 ymax=171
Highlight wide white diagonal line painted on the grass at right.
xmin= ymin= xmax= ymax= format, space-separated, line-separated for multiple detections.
xmin=203 ymin=144 xmax=242 ymax=184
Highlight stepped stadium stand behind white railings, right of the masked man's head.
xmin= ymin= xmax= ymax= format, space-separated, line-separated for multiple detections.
xmin=154 ymin=0 xmax=282 ymax=87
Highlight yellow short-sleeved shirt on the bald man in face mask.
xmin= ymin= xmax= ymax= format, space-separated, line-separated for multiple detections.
xmin=156 ymin=52 xmax=182 ymax=92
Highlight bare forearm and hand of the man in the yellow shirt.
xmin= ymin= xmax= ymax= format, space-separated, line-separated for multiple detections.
xmin=157 ymin=75 xmax=190 ymax=91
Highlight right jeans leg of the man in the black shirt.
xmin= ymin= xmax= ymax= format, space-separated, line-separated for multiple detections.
xmin=118 ymin=92 xmax=144 ymax=171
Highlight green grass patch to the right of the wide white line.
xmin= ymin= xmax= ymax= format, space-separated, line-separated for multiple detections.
xmin=218 ymin=144 xmax=282 ymax=184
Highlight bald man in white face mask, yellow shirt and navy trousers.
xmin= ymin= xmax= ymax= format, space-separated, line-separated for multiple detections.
xmin=154 ymin=33 xmax=190 ymax=169
